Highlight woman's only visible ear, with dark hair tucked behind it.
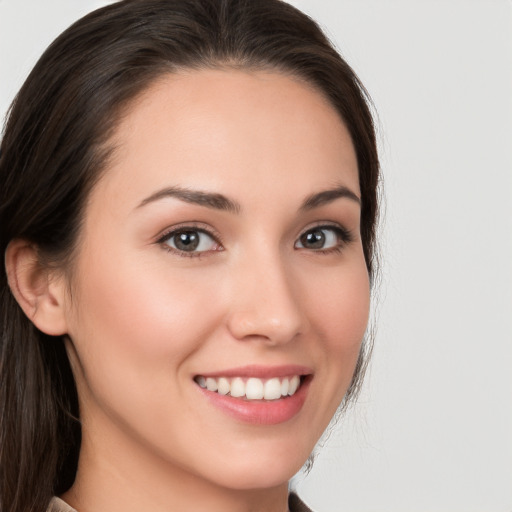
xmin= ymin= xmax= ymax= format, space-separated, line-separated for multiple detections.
xmin=5 ymin=239 xmax=67 ymax=336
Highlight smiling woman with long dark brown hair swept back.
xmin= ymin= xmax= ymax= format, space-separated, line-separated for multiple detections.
xmin=0 ymin=0 xmax=378 ymax=512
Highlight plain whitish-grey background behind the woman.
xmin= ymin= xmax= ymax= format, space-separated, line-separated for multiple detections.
xmin=0 ymin=0 xmax=512 ymax=512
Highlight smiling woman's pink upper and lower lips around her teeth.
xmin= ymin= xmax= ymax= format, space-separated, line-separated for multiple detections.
xmin=197 ymin=365 xmax=313 ymax=425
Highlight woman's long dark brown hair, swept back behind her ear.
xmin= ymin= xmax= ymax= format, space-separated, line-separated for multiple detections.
xmin=0 ymin=0 xmax=379 ymax=512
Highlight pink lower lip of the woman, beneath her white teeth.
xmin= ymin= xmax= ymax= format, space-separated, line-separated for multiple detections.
xmin=197 ymin=376 xmax=311 ymax=425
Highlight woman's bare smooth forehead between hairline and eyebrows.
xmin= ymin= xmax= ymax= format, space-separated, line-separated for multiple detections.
xmin=91 ymin=70 xmax=359 ymax=210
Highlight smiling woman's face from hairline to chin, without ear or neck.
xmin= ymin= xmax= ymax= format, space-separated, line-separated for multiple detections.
xmin=62 ymin=70 xmax=369 ymax=490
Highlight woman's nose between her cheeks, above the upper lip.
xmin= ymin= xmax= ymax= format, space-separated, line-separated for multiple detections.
xmin=228 ymin=251 xmax=305 ymax=345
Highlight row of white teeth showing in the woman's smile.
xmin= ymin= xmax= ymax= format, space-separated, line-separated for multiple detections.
xmin=195 ymin=375 xmax=300 ymax=400
